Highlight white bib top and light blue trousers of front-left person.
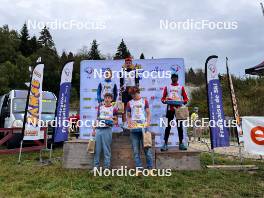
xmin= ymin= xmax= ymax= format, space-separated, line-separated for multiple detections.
xmin=94 ymin=105 xmax=117 ymax=168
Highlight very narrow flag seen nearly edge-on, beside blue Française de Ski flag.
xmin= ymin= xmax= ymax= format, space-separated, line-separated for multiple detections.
xmin=226 ymin=58 xmax=243 ymax=144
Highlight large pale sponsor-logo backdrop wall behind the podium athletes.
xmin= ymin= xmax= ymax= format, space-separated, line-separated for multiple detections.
xmin=80 ymin=58 xmax=186 ymax=146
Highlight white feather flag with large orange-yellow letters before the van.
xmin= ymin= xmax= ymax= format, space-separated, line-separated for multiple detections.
xmin=22 ymin=63 xmax=44 ymax=140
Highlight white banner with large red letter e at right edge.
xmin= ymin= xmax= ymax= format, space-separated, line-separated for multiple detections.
xmin=242 ymin=116 xmax=264 ymax=155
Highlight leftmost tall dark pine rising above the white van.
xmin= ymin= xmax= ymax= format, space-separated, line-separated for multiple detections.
xmin=19 ymin=23 xmax=32 ymax=56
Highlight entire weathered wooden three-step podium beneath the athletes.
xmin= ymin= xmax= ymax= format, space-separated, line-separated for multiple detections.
xmin=63 ymin=133 xmax=201 ymax=170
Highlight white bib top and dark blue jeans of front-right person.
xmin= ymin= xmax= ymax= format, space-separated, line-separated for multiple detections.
xmin=126 ymin=98 xmax=153 ymax=169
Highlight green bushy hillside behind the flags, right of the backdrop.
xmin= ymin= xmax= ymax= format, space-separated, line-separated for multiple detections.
xmin=188 ymin=70 xmax=264 ymax=117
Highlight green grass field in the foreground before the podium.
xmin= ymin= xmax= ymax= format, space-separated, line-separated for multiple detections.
xmin=0 ymin=149 xmax=264 ymax=198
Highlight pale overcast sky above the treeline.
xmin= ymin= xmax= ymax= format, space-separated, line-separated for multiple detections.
xmin=0 ymin=0 xmax=264 ymax=77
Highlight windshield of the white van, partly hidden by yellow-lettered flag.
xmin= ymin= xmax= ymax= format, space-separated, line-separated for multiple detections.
xmin=13 ymin=98 xmax=56 ymax=114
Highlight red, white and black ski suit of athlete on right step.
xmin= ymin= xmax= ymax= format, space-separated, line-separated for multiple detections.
xmin=161 ymin=83 xmax=189 ymax=148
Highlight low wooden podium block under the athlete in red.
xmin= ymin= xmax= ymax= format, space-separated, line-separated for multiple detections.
xmin=155 ymin=148 xmax=201 ymax=170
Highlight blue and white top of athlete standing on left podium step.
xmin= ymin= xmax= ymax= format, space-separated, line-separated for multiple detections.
xmin=97 ymin=79 xmax=117 ymax=103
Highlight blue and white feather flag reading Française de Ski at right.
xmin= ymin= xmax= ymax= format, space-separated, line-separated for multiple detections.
xmin=205 ymin=55 xmax=229 ymax=149
